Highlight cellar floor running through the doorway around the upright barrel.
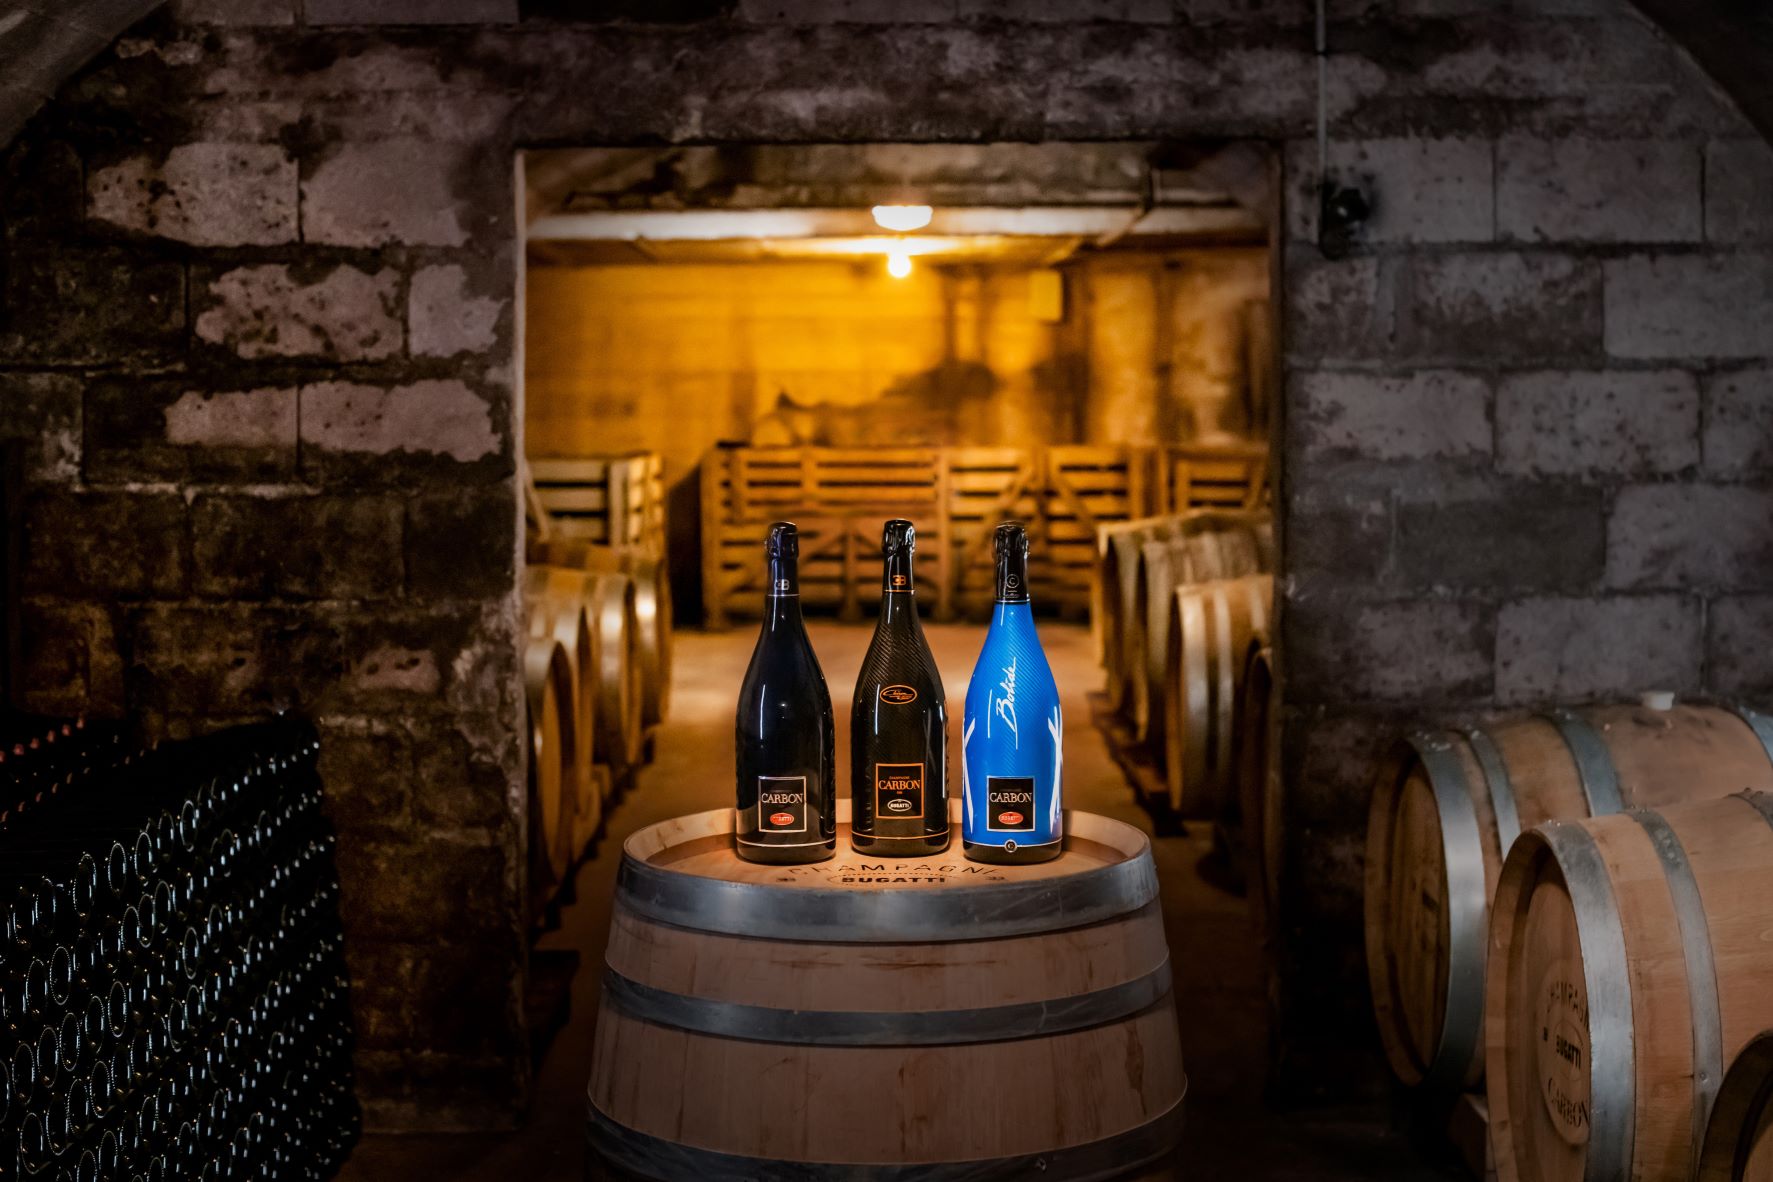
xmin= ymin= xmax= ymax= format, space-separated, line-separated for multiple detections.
xmin=340 ymin=622 xmax=1463 ymax=1182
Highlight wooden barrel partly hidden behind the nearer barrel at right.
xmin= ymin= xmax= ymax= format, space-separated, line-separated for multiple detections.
xmin=1365 ymin=705 xmax=1773 ymax=1092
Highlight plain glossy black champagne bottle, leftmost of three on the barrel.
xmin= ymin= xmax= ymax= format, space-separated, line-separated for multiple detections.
xmin=734 ymin=521 xmax=837 ymax=865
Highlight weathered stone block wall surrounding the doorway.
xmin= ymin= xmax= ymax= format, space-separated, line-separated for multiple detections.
xmin=0 ymin=0 xmax=1773 ymax=1127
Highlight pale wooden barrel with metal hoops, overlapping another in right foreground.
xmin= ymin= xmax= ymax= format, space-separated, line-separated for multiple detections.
xmin=1484 ymin=792 xmax=1773 ymax=1182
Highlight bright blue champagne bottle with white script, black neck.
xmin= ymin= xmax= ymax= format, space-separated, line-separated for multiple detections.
xmin=961 ymin=521 xmax=1066 ymax=863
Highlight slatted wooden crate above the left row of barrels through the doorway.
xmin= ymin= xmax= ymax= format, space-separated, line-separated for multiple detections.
xmin=528 ymin=452 xmax=665 ymax=553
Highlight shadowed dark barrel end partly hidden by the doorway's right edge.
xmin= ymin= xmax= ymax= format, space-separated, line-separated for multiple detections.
xmin=1232 ymin=638 xmax=1284 ymax=953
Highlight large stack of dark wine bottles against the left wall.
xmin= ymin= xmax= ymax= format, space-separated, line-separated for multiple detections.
xmin=0 ymin=719 xmax=358 ymax=1182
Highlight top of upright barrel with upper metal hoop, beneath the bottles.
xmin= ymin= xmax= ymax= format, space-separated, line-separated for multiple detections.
xmin=617 ymin=801 xmax=1158 ymax=943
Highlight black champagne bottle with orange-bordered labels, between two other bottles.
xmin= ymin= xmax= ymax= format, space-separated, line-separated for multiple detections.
xmin=849 ymin=519 xmax=949 ymax=858
